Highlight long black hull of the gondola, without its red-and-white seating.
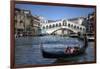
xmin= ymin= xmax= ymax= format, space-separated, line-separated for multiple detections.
xmin=41 ymin=35 xmax=88 ymax=58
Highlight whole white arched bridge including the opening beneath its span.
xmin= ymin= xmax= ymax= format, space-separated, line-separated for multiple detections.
xmin=41 ymin=20 xmax=86 ymax=34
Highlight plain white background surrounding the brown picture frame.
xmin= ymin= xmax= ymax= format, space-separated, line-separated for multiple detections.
xmin=0 ymin=0 xmax=100 ymax=69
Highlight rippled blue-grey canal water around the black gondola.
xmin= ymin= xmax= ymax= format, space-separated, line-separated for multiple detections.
xmin=15 ymin=35 xmax=95 ymax=65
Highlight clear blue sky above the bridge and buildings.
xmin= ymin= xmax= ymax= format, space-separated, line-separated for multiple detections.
xmin=15 ymin=4 xmax=95 ymax=20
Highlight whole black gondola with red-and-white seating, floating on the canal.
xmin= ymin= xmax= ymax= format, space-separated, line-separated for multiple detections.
xmin=41 ymin=36 xmax=88 ymax=58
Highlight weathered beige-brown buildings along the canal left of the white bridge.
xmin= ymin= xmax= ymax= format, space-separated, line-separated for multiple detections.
xmin=14 ymin=8 xmax=40 ymax=36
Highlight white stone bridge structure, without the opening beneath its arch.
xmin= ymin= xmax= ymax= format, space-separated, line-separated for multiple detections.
xmin=42 ymin=20 xmax=86 ymax=34
